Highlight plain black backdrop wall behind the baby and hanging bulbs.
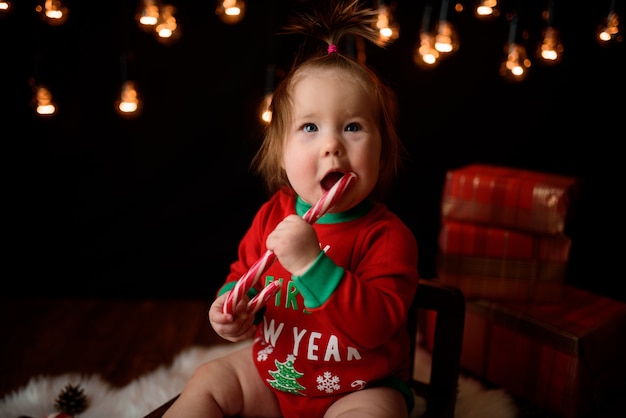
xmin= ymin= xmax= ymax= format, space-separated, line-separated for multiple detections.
xmin=0 ymin=0 xmax=626 ymax=300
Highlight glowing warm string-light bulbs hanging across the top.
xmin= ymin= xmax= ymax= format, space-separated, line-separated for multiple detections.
xmin=0 ymin=0 xmax=623 ymax=116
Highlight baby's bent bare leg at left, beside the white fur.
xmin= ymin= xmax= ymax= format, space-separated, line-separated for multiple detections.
xmin=163 ymin=347 xmax=281 ymax=418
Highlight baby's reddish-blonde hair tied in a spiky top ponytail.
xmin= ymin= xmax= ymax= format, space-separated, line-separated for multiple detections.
xmin=252 ymin=0 xmax=404 ymax=202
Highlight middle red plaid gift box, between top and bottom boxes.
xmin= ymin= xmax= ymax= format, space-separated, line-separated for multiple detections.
xmin=437 ymin=220 xmax=571 ymax=301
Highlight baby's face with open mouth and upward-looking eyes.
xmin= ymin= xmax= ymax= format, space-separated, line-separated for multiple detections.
xmin=283 ymin=69 xmax=381 ymax=212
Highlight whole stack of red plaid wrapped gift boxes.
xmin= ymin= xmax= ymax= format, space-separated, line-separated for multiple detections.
xmin=423 ymin=164 xmax=626 ymax=418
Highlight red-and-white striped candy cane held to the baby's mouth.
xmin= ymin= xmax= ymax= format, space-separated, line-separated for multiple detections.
xmin=223 ymin=173 xmax=356 ymax=314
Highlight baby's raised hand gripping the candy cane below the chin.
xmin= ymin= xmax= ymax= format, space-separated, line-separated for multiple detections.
xmin=265 ymin=215 xmax=321 ymax=276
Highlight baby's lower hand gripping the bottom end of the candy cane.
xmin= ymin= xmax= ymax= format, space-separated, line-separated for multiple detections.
xmin=209 ymin=293 xmax=257 ymax=342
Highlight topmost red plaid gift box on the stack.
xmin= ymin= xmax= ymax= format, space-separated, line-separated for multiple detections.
xmin=441 ymin=164 xmax=578 ymax=234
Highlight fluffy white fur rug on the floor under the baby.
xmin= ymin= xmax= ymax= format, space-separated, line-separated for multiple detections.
xmin=0 ymin=342 xmax=517 ymax=418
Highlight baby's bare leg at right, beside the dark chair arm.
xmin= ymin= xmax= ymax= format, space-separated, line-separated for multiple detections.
xmin=324 ymin=386 xmax=409 ymax=418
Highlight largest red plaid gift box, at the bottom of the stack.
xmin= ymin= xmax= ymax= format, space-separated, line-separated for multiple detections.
xmin=422 ymin=285 xmax=626 ymax=418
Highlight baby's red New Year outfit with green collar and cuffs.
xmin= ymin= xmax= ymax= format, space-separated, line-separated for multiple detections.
xmin=220 ymin=188 xmax=418 ymax=417
